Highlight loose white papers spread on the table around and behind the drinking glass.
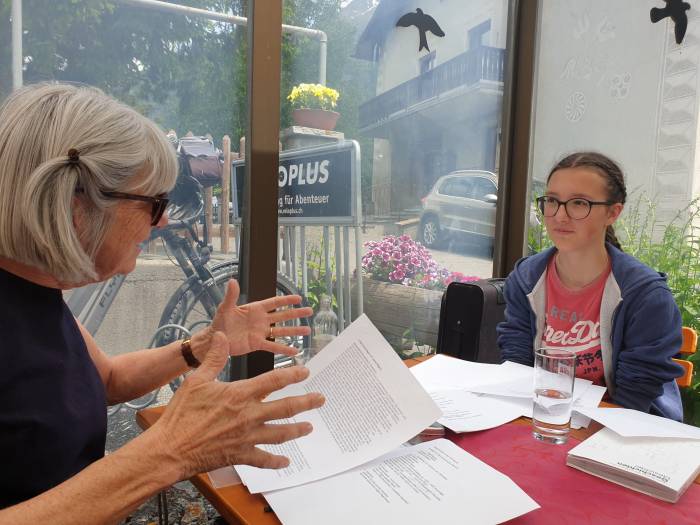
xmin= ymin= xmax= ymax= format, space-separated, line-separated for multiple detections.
xmin=411 ymin=354 xmax=605 ymax=432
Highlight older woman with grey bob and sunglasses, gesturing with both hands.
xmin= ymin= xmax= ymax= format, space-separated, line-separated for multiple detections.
xmin=0 ymin=84 xmax=323 ymax=524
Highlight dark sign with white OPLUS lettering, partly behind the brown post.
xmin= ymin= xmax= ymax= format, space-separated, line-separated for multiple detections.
xmin=233 ymin=141 xmax=359 ymax=224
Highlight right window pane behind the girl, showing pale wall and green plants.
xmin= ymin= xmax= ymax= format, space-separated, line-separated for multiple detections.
xmin=530 ymin=0 xmax=700 ymax=425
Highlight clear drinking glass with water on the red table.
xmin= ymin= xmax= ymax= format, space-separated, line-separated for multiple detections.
xmin=532 ymin=348 xmax=576 ymax=444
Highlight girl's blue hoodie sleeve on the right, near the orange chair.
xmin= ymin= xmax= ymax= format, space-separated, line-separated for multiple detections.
xmin=612 ymin=287 xmax=683 ymax=417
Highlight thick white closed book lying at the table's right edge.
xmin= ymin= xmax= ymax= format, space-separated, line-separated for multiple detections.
xmin=566 ymin=428 xmax=700 ymax=503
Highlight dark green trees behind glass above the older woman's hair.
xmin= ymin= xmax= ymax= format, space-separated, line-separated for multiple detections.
xmin=0 ymin=0 xmax=242 ymax=136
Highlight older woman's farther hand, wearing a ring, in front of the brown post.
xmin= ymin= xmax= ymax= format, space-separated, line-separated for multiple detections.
xmin=211 ymin=279 xmax=313 ymax=356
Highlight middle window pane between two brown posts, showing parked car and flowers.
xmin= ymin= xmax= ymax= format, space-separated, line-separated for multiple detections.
xmin=280 ymin=0 xmax=507 ymax=356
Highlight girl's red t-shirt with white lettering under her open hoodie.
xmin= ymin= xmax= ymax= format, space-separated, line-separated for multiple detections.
xmin=542 ymin=257 xmax=610 ymax=385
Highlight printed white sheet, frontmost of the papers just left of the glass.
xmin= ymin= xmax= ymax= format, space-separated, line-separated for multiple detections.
xmin=430 ymin=390 xmax=532 ymax=432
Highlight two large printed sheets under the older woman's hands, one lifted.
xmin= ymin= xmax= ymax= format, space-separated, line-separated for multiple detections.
xmin=227 ymin=316 xmax=538 ymax=525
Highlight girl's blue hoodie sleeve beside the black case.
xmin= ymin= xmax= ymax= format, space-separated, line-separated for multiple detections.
xmin=496 ymin=266 xmax=534 ymax=366
